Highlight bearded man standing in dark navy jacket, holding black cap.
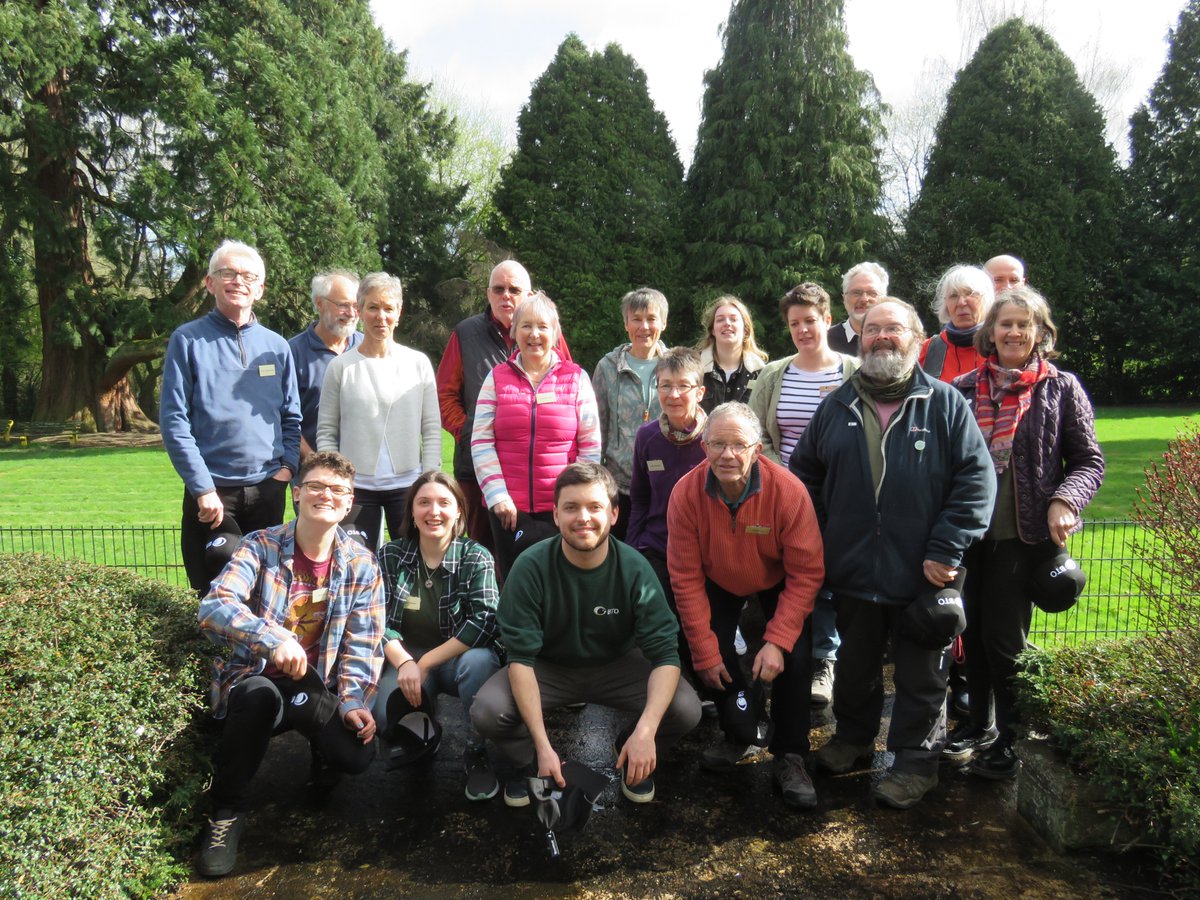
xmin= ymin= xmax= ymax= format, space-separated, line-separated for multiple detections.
xmin=791 ymin=298 xmax=996 ymax=809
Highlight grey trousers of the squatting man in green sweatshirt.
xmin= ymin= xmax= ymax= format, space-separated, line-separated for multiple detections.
xmin=470 ymin=649 xmax=700 ymax=767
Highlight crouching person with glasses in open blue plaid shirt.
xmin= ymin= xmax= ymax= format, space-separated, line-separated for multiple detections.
xmin=197 ymin=452 xmax=384 ymax=877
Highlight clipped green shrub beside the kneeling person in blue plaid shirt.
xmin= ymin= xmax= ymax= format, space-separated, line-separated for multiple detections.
xmin=0 ymin=554 xmax=211 ymax=896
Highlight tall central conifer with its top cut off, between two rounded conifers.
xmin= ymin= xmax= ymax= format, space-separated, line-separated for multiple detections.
xmin=688 ymin=0 xmax=882 ymax=350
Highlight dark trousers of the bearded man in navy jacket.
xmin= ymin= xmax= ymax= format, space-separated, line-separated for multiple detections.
xmin=833 ymin=596 xmax=950 ymax=775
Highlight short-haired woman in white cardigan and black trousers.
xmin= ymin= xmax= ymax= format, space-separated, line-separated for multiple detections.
xmin=317 ymin=272 xmax=442 ymax=550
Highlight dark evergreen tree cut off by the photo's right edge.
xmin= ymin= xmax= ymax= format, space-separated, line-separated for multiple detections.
xmin=1122 ymin=0 xmax=1200 ymax=400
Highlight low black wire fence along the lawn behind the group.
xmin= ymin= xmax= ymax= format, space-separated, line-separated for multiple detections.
xmin=0 ymin=520 xmax=1200 ymax=647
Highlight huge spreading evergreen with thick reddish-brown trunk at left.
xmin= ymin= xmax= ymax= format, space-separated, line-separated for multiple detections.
xmin=0 ymin=0 xmax=461 ymax=430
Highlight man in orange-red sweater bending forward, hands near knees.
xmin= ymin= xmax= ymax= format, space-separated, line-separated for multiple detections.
xmin=667 ymin=403 xmax=824 ymax=809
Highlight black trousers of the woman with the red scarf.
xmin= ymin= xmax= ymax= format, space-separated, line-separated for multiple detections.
xmin=962 ymin=539 xmax=1034 ymax=739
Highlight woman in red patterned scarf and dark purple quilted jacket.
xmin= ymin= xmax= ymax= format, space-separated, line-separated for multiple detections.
xmin=943 ymin=286 xmax=1104 ymax=780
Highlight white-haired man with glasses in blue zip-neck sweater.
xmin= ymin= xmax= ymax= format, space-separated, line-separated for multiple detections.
xmin=158 ymin=241 xmax=300 ymax=596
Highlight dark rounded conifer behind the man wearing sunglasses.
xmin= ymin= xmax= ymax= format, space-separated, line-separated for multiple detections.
xmin=492 ymin=34 xmax=686 ymax=368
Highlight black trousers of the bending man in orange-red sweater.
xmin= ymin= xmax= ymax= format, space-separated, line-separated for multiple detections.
xmin=704 ymin=580 xmax=812 ymax=756
